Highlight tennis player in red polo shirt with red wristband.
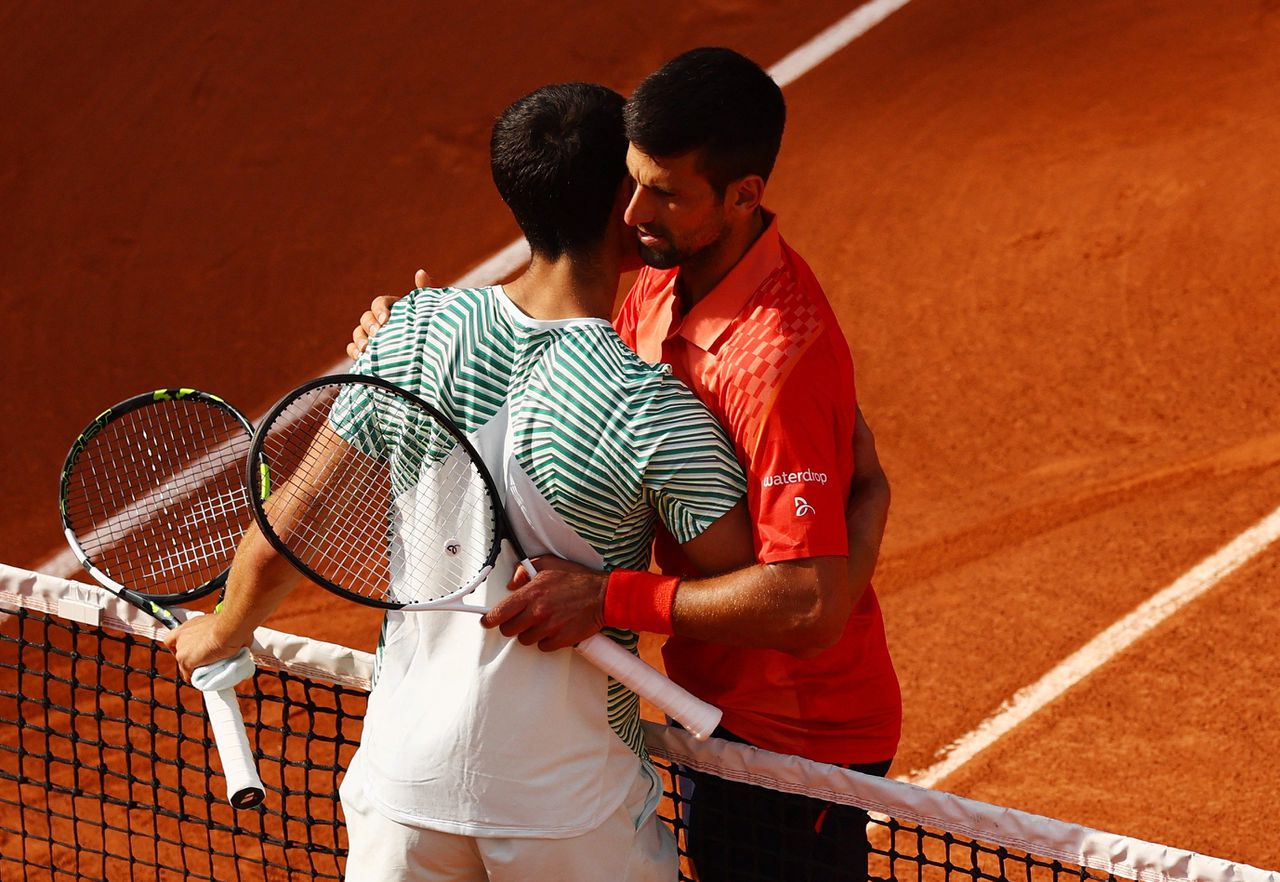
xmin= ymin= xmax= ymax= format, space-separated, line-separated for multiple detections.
xmin=355 ymin=49 xmax=901 ymax=882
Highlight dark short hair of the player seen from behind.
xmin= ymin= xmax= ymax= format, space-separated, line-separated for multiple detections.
xmin=489 ymin=83 xmax=627 ymax=259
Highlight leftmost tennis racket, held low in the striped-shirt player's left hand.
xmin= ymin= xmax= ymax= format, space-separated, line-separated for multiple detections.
xmin=59 ymin=389 xmax=262 ymax=808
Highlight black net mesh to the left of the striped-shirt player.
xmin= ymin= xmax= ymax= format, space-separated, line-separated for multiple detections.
xmin=0 ymin=601 xmax=365 ymax=882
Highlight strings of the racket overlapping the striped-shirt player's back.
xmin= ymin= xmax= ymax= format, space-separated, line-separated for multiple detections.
xmin=260 ymin=384 xmax=497 ymax=605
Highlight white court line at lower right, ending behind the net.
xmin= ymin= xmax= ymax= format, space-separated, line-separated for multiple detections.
xmin=905 ymin=499 xmax=1280 ymax=787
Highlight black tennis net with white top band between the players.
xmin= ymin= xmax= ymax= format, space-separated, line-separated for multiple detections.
xmin=0 ymin=565 xmax=1280 ymax=882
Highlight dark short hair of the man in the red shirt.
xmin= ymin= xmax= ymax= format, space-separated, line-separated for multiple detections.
xmin=626 ymin=47 xmax=787 ymax=192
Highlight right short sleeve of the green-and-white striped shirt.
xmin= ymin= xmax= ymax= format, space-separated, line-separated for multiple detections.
xmin=639 ymin=375 xmax=746 ymax=544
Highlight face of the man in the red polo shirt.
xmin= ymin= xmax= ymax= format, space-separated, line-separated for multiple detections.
xmin=623 ymin=145 xmax=730 ymax=269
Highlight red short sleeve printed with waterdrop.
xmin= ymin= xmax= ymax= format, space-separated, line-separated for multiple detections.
xmin=748 ymin=344 xmax=856 ymax=563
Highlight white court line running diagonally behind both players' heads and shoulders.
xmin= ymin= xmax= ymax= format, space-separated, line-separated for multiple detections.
xmin=32 ymin=0 xmax=910 ymax=579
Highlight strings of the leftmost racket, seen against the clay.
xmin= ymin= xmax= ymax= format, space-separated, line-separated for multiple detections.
xmin=65 ymin=398 xmax=250 ymax=595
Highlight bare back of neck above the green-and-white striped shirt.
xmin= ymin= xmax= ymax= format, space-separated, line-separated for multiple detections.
xmin=503 ymin=244 xmax=618 ymax=321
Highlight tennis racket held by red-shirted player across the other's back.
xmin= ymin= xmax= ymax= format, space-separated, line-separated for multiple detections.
xmin=250 ymin=375 xmax=721 ymax=739
